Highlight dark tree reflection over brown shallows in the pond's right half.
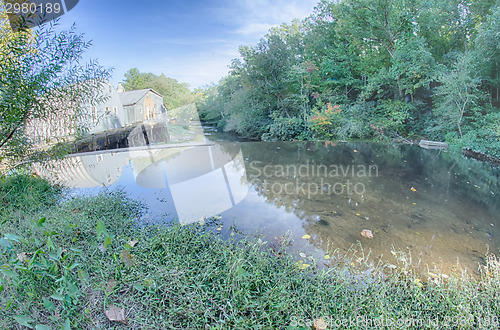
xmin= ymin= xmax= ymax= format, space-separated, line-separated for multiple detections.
xmin=238 ymin=142 xmax=500 ymax=274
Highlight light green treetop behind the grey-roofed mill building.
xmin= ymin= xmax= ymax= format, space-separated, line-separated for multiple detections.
xmin=123 ymin=68 xmax=202 ymax=109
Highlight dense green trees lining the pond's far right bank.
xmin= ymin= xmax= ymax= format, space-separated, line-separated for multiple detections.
xmin=199 ymin=0 xmax=500 ymax=157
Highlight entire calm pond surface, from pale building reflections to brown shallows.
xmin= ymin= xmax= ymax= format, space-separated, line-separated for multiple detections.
xmin=37 ymin=132 xmax=500 ymax=271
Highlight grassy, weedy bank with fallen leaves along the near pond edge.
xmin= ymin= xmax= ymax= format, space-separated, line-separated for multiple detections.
xmin=0 ymin=175 xmax=500 ymax=329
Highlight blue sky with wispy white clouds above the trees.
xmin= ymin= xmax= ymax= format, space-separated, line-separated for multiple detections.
xmin=53 ymin=0 xmax=319 ymax=89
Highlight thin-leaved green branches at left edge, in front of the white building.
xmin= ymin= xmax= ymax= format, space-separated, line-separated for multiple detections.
xmin=0 ymin=13 xmax=110 ymax=166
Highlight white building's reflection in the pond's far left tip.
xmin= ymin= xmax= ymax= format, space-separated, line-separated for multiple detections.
xmin=33 ymin=153 xmax=128 ymax=188
